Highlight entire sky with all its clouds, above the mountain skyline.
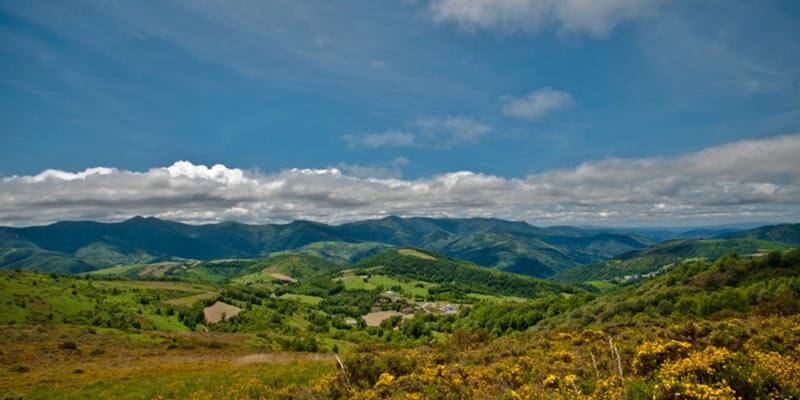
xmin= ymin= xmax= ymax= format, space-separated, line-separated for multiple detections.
xmin=0 ymin=0 xmax=800 ymax=226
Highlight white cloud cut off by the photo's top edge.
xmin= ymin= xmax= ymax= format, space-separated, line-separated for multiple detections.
xmin=428 ymin=0 xmax=661 ymax=37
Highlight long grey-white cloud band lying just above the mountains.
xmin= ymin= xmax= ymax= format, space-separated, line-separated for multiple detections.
xmin=0 ymin=134 xmax=800 ymax=225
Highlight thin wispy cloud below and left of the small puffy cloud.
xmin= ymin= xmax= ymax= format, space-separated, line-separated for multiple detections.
xmin=342 ymin=116 xmax=492 ymax=148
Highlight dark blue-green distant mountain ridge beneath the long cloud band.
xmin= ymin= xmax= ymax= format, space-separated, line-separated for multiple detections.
xmin=0 ymin=217 xmax=653 ymax=277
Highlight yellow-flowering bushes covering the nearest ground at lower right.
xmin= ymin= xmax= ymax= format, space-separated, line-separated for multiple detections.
xmin=314 ymin=318 xmax=800 ymax=400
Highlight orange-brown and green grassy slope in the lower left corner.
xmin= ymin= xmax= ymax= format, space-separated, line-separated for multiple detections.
xmin=0 ymin=326 xmax=336 ymax=399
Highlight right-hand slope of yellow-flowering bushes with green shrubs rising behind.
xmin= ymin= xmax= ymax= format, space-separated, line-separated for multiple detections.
xmin=322 ymin=250 xmax=800 ymax=399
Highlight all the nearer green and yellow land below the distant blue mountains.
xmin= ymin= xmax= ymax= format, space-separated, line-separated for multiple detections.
xmin=0 ymin=244 xmax=800 ymax=399
